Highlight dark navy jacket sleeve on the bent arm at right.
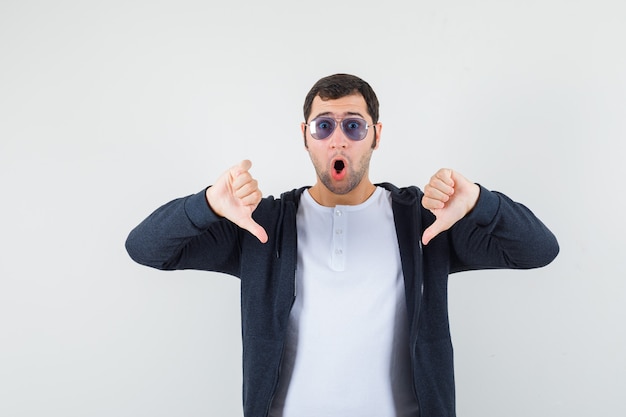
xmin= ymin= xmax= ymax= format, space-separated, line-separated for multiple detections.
xmin=450 ymin=186 xmax=559 ymax=272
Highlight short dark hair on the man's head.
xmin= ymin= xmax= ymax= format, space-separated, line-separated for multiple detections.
xmin=303 ymin=74 xmax=378 ymax=123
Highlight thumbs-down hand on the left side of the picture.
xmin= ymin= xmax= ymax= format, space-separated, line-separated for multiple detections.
xmin=206 ymin=160 xmax=268 ymax=243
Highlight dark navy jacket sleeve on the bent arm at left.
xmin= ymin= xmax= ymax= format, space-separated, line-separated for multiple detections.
xmin=126 ymin=190 xmax=240 ymax=276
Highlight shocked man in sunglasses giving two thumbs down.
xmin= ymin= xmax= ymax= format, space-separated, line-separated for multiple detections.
xmin=126 ymin=74 xmax=559 ymax=417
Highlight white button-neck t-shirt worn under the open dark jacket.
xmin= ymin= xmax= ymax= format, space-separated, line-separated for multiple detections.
xmin=270 ymin=187 xmax=418 ymax=417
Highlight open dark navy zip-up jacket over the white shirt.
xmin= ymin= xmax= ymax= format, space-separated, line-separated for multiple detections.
xmin=126 ymin=183 xmax=559 ymax=417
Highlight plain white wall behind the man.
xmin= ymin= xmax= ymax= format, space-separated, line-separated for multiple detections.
xmin=0 ymin=0 xmax=626 ymax=417
